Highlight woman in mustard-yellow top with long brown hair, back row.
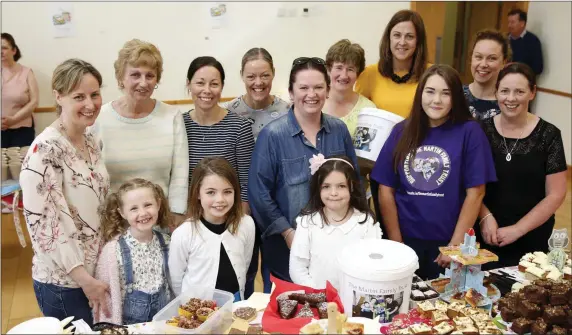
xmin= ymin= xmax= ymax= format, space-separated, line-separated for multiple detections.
xmin=356 ymin=10 xmax=430 ymax=228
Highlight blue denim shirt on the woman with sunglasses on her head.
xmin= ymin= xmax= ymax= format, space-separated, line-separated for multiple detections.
xmin=248 ymin=107 xmax=359 ymax=241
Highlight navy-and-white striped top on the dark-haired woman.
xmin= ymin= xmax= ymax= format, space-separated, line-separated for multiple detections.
xmin=183 ymin=112 xmax=254 ymax=201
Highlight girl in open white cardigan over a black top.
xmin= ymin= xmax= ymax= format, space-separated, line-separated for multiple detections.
xmin=169 ymin=157 xmax=255 ymax=300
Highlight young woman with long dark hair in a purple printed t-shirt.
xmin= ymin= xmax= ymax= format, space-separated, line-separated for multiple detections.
xmin=372 ymin=65 xmax=496 ymax=279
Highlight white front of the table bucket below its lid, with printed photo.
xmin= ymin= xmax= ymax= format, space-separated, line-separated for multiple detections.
xmin=340 ymin=274 xmax=412 ymax=323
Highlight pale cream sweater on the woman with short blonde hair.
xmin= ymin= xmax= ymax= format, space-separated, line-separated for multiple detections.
xmin=91 ymin=100 xmax=189 ymax=214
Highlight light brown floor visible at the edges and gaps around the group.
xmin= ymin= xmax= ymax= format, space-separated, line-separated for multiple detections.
xmin=0 ymin=180 xmax=572 ymax=334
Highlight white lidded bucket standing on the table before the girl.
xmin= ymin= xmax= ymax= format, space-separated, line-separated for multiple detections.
xmin=337 ymin=240 xmax=419 ymax=323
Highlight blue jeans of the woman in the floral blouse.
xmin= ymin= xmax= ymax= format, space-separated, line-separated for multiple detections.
xmin=34 ymin=280 xmax=93 ymax=327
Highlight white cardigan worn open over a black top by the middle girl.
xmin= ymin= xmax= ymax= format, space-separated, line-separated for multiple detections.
xmin=169 ymin=215 xmax=255 ymax=296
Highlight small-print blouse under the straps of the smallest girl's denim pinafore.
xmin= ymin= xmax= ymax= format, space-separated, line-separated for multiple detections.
xmin=115 ymin=230 xmax=171 ymax=300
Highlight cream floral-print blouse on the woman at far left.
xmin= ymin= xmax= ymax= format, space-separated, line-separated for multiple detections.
xmin=20 ymin=127 xmax=109 ymax=288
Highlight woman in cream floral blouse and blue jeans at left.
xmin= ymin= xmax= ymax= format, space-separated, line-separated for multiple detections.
xmin=20 ymin=59 xmax=109 ymax=325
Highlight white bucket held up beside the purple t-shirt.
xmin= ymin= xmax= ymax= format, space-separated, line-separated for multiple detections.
xmin=354 ymin=107 xmax=404 ymax=162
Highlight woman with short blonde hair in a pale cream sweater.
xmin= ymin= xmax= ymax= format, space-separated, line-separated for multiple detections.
xmin=94 ymin=39 xmax=189 ymax=226
